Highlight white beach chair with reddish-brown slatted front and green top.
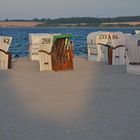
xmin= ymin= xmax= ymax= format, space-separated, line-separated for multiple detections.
xmin=39 ymin=34 xmax=73 ymax=71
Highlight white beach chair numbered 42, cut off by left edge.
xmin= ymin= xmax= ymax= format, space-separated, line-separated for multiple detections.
xmin=0 ymin=36 xmax=12 ymax=70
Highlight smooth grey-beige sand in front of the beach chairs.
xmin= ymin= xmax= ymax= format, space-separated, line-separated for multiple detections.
xmin=0 ymin=58 xmax=140 ymax=140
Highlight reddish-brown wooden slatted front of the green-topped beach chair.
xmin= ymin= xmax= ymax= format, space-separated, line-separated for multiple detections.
xmin=51 ymin=37 xmax=73 ymax=71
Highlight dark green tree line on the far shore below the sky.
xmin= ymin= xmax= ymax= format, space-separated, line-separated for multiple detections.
xmin=0 ymin=16 xmax=140 ymax=27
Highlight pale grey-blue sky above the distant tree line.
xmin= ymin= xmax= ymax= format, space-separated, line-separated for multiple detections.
xmin=0 ymin=0 xmax=140 ymax=20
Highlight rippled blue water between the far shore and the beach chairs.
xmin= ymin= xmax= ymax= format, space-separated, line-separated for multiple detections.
xmin=0 ymin=27 xmax=138 ymax=57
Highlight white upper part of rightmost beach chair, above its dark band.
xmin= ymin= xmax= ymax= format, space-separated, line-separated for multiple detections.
xmin=127 ymin=34 xmax=140 ymax=64
